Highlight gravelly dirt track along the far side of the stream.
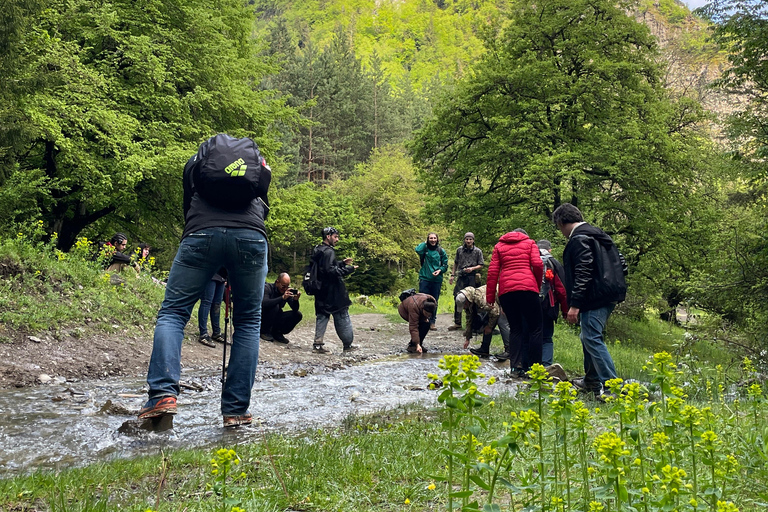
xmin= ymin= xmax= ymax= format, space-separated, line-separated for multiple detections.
xmin=0 ymin=313 xmax=474 ymax=388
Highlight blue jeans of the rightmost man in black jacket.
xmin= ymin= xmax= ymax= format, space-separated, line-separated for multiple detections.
xmin=579 ymin=305 xmax=616 ymax=387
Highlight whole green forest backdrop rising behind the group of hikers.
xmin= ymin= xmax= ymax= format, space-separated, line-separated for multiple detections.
xmin=0 ymin=0 xmax=768 ymax=344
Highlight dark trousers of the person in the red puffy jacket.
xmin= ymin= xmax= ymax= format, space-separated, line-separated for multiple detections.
xmin=499 ymin=291 xmax=542 ymax=371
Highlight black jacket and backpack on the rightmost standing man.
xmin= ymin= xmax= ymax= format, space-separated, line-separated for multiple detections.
xmin=563 ymin=224 xmax=627 ymax=311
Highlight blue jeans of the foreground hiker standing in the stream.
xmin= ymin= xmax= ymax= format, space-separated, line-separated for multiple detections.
xmin=145 ymin=228 xmax=267 ymax=416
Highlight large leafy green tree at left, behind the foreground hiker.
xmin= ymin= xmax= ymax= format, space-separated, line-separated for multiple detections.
xmin=0 ymin=0 xmax=292 ymax=249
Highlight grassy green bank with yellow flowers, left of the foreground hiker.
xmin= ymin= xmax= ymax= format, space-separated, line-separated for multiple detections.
xmin=0 ymin=221 xmax=165 ymax=335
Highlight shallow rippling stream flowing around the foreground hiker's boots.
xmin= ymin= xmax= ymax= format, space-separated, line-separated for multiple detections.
xmin=0 ymin=354 xmax=508 ymax=476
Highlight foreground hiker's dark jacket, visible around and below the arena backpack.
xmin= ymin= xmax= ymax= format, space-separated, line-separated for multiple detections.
xmin=182 ymin=156 xmax=269 ymax=238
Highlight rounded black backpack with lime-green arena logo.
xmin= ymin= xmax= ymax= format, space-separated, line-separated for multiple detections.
xmin=185 ymin=133 xmax=272 ymax=211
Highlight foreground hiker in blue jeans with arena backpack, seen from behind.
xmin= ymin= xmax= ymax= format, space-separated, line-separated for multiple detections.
xmin=139 ymin=134 xmax=272 ymax=427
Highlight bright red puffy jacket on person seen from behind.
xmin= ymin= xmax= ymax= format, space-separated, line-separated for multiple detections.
xmin=485 ymin=231 xmax=544 ymax=304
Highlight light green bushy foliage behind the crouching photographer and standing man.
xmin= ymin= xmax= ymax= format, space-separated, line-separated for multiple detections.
xmin=268 ymin=146 xmax=428 ymax=294
